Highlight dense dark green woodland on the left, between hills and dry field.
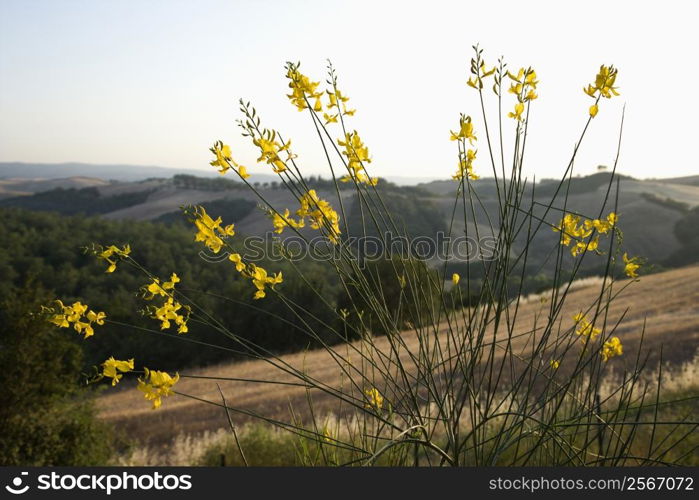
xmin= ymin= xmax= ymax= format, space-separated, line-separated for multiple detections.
xmin=0 ymin=209 xmax=344 ymax=370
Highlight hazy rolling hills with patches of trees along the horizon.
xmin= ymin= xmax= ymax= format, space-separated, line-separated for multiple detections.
xmin=0 ymin=171 xmax=699 ymax=272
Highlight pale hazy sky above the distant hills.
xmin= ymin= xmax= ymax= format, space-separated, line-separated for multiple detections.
xmin=0 ymin=0 xmax=699 ymax=182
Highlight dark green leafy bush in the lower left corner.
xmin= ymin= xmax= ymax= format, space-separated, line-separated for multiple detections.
xmin=0 ymin=283 xmax=111 ymax=466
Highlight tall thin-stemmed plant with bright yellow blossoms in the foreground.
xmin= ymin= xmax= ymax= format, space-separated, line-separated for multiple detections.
xmin=41 ymin=47 xmax=697 ymax=466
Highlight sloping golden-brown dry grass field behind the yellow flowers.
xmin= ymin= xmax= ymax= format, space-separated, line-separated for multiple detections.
xmin=98 ymin=266 xmax=699 ymax=445
